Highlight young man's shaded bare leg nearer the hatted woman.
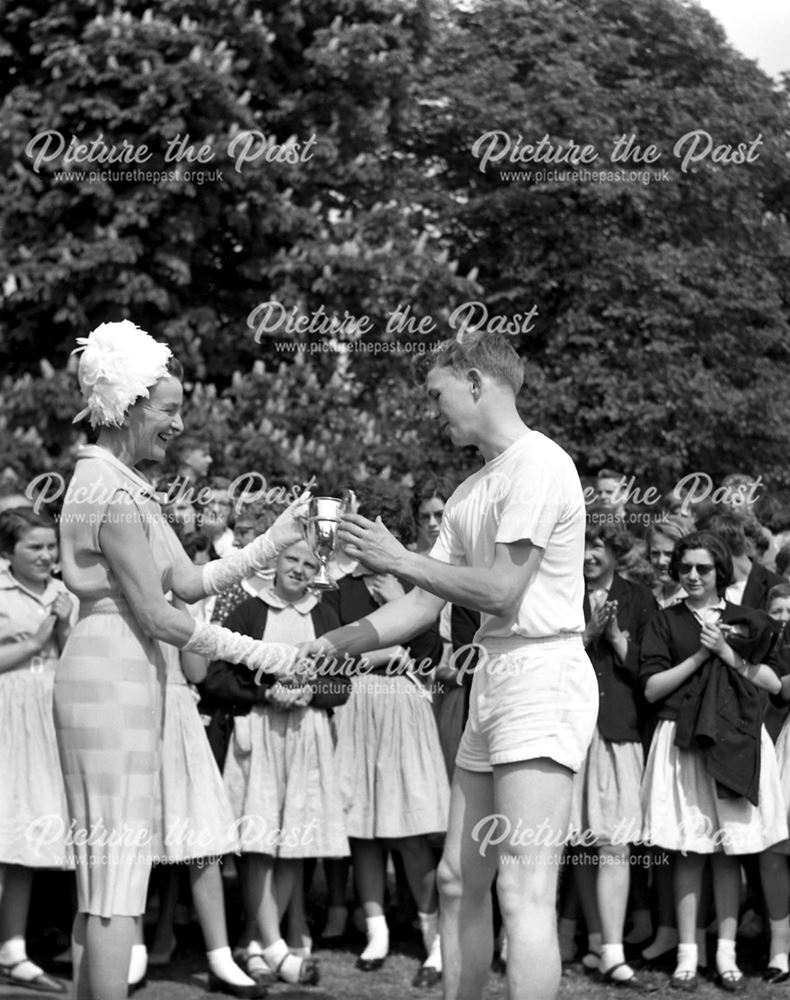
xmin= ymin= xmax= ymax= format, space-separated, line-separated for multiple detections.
xmin=437 ymin=767 xmax=497 ymax=1000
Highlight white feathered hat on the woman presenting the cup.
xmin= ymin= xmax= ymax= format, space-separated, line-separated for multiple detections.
xmin=71 ymin=319 xmax=172 ymax=427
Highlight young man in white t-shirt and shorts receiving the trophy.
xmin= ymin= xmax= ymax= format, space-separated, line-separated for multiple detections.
xmin=304 ymin=334 xmax=598 ymax=1000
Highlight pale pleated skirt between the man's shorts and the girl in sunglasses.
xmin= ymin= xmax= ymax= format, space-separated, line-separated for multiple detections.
xmin=570 ymin=726 xmax=644 ymax=847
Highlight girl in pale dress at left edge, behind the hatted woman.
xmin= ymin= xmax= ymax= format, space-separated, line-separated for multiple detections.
xmin=0 ymin=507 xmax=75 ymax=993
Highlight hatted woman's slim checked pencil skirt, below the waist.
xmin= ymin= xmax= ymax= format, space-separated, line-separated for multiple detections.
xmin=54 ymin=598 xmax=164 ymax=917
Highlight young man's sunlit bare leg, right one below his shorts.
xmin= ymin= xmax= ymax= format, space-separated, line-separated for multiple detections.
xmin=494 ymin=758 xmax=572 ymax=1000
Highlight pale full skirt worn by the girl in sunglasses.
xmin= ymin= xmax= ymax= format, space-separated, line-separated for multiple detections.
xmin=642 ymin=719 xmax=788 ymax=854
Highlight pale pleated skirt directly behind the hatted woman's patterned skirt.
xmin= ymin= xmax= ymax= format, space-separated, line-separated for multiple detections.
xmin=156 ymin=684 xmax=239 ymax=864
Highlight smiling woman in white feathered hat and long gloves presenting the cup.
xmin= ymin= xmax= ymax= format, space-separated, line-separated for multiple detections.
xmin=54 ymin=320 xmax=304 ymax=1000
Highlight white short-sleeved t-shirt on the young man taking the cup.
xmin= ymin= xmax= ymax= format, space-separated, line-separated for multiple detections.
xmin=430 ymin=431 xmax=586 ymax=648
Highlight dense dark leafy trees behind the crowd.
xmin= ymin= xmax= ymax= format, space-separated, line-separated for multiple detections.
xmin=0 ymin=0 xmax=790 ymax=498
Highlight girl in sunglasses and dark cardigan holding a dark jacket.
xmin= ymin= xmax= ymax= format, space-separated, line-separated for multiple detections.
xmin=640 ymin=531 xmax=787 ymax=993
